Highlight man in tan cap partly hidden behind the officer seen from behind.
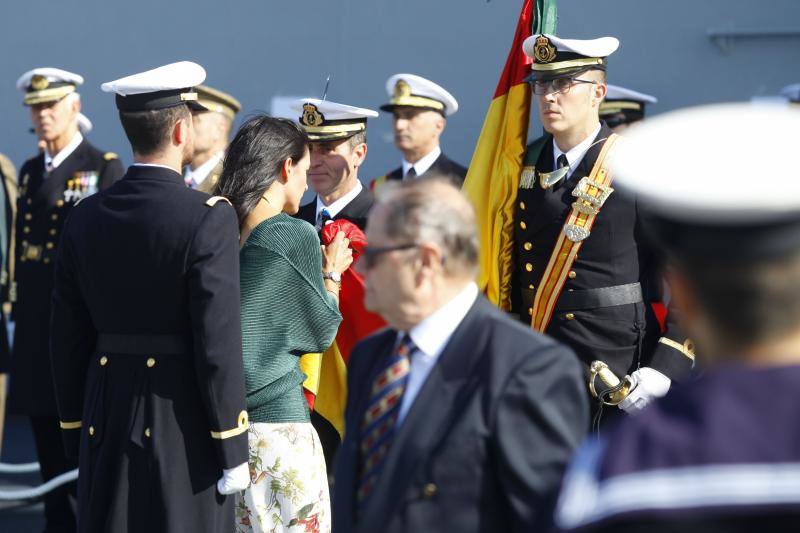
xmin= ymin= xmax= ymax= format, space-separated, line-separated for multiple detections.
xmin=183 ymin=85 xmax=242 ymax=194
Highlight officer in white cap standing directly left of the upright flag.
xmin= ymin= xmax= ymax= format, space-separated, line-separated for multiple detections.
xmin=371 ymin=74 xmax=467 ymax=191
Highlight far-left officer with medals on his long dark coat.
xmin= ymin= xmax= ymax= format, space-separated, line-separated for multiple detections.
xmin=9 ymin=68 xmax=122 ymax=531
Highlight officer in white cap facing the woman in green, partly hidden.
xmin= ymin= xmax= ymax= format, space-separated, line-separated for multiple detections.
xmin=293 ymin=98 xmax=378 ymax=231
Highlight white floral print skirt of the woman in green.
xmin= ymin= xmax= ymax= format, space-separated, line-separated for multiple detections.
xmin=236 ymin=422 xmax=331 ymax=533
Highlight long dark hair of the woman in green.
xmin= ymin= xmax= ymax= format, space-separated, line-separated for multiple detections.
xmin=215 ymin=115 xmax=308 ymax=225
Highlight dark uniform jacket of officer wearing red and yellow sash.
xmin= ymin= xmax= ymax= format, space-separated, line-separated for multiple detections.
xmin=511 ymin=125 xmax=693 ymax=378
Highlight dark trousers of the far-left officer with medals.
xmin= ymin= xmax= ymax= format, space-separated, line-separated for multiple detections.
xmin=31 ymin=416 xmax=78 ymax=533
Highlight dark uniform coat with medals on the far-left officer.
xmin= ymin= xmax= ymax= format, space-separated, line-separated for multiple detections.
xmin=9 ymin=140 xmax=124 ymax=416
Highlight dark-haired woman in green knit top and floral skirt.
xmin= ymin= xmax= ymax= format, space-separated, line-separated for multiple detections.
xmin=218 ymin=116 xmax=352 ymax=533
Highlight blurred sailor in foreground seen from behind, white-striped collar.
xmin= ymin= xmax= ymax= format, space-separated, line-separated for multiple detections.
xmin=556 ymin=104 xmax=800 ymax=533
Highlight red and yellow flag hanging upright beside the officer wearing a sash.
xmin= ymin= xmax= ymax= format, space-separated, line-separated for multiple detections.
xmin=463 ymin=0 xmax=556 ymax=310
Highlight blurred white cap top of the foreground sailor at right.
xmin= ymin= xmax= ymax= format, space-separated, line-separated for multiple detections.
xmin=612 ymin=103 xmax=800 ymax=225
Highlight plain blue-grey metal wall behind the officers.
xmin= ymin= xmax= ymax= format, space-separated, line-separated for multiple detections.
xmin=0 ymin=0 xmax=800 ymax=181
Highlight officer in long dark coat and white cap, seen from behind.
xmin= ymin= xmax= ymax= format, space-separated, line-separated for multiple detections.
xmin=52 ymin=62 xmax=249 ymax=533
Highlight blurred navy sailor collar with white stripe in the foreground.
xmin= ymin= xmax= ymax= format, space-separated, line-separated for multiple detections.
xmin=555 ymin=366 xmax=800 ymax=533
